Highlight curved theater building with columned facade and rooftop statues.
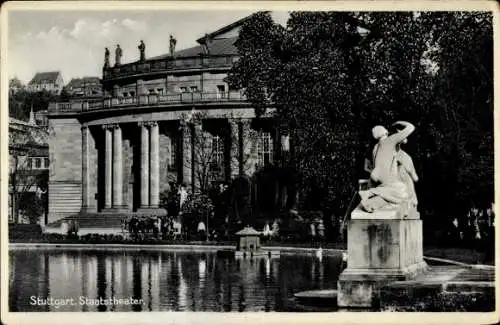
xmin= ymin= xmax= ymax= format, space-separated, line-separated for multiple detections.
xmin=48 ymin=15 xmax=287 ymax=228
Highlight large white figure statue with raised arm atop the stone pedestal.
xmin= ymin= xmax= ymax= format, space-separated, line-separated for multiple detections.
xmin=359 ymin=121 xmax=417 ymax=212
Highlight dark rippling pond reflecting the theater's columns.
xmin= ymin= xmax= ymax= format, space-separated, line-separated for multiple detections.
xmin=9 ymin=250 xmax=340 ymax=312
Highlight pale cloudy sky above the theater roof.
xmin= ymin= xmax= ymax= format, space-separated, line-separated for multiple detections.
xmin=7 ymin=10 xmax=288 ymax=84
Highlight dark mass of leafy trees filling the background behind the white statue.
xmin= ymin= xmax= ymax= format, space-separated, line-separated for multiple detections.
xmin=228 ymin=12 xmax=493 ymax=239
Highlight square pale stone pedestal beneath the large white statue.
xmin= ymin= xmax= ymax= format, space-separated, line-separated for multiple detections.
xmin=338 ymin=204 xmax=427 ymax=308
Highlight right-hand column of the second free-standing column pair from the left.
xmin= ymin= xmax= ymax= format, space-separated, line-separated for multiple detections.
xmin=149 ymin=122 xmax=160 ymax=208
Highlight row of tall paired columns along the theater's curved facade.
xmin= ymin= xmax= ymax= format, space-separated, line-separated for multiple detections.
xmin=81 ymin=119 xmax=258 ymax=212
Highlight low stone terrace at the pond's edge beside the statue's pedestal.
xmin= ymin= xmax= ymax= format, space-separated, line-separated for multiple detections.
xmin=295 ymin=264 xmax=495 ymax=312
